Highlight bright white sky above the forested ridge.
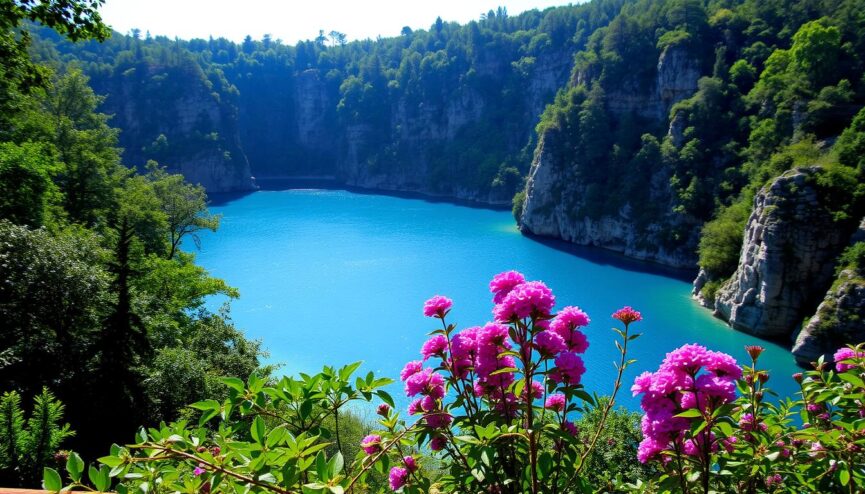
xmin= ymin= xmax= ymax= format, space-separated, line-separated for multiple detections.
xmin=100 ymin=0 xmax=580 ymax=45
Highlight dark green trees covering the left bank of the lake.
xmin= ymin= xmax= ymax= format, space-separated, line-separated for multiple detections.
xmin=0 ymin=1 xmax=260 ymax=464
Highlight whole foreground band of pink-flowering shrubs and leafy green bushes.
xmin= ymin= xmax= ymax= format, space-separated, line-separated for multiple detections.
xmin=43 ymin=271 xmax=865 ymax=494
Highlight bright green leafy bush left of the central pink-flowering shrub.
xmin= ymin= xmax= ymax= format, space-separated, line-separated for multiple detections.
xmin=45 ymin=362 xmax=392 ymax=493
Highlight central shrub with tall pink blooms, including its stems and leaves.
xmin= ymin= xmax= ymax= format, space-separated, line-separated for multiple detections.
xmin=361 ymin=271 xmax=642 ymax=493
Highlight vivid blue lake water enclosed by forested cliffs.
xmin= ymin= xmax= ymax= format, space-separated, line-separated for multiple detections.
xmin=198 ymin=190 xmax=797 ymax=408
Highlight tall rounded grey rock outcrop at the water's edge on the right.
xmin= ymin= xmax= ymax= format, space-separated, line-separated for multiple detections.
xmin=715 ymin=167 xmax=852 ymax=337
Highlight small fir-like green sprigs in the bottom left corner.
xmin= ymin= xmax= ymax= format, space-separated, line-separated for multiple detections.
xmin=0 ymin=388 xmax=74 ymax=486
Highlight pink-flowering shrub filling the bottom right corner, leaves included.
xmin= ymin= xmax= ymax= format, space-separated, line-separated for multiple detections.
xmin=628 ymin=345 xmax=865 ymax=493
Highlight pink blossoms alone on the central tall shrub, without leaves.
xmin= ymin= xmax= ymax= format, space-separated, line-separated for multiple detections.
xmin=412 ymin=271 xmax=589 ymax=416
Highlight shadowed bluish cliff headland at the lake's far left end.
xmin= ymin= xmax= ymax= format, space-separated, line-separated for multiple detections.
xmin=94 ymin=63 xmax=256 ymax=192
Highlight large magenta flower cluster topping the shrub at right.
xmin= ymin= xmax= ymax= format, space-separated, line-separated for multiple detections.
xmin=631 ymin=345 xmax=742 ymax=463
